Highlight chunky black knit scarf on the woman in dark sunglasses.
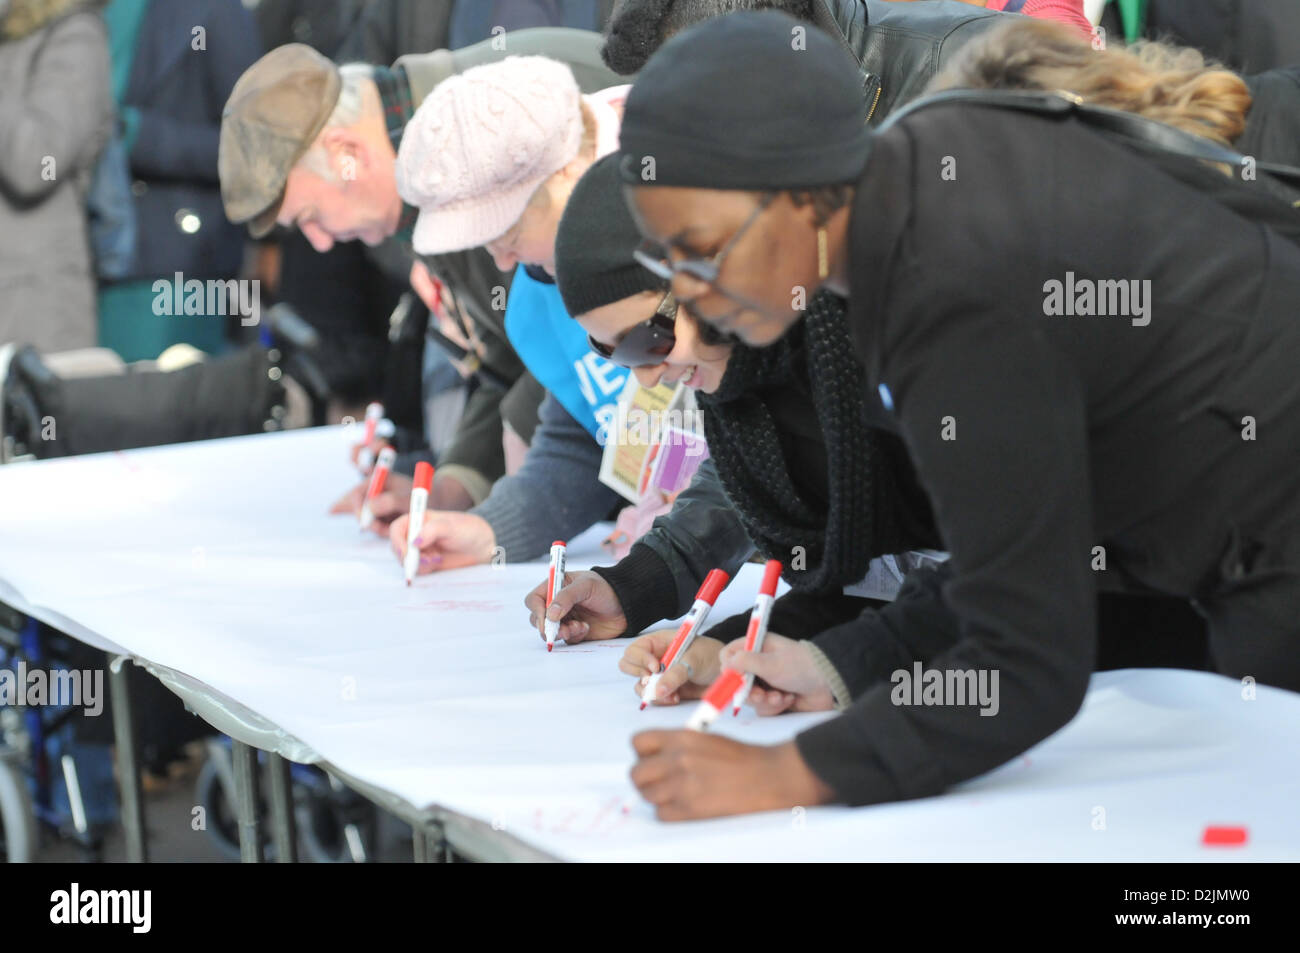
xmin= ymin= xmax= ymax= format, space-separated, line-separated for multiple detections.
xmin=698 ymin=293 xmax=930 ymax=592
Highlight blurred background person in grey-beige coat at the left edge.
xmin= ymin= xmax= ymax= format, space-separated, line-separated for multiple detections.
xmin=0 ymin=0 xmax=113 ymax=351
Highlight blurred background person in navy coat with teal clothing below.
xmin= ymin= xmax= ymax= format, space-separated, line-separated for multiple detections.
xmin=96 ymin=0 xmax=261 ymax=360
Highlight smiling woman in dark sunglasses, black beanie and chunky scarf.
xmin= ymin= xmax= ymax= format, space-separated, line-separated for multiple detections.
xmin=525 ymin=150 xmax=939 ymax=703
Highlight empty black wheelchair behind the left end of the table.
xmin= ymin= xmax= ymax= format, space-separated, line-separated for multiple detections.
xmin=0 ymin=304 xmax=345 ymax=862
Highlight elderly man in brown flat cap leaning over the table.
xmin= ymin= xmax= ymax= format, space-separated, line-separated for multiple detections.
xmin=218 ymin=27 xmax=618 ymax=516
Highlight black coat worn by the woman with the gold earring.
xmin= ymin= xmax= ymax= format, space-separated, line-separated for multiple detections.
xmin=797 ymin=105 xmax=1300 ymax=805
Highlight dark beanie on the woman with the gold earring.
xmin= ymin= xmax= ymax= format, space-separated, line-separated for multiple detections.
xmin=619 ymin=10 xmax=872 ymax=190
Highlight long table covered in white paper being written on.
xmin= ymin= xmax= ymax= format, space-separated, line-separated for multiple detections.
xmin=0 ymin=428 xmax=1300 ymax=861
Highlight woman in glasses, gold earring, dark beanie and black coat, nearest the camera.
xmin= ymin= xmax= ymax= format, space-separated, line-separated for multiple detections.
xmin=620 ymin=13 xmax=1300 ymax=819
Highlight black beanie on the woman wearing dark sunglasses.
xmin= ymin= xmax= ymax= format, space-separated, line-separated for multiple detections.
xmin=555 ymin=153 xmax=667 ymax=316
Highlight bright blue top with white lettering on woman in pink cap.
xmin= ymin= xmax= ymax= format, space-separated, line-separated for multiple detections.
xmin=506 ymin=265 xmax=628 ymax=441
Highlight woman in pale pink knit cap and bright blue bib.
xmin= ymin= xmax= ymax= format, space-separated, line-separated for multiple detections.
xmin=390 ymin=56 xmax=642 ymax=571
